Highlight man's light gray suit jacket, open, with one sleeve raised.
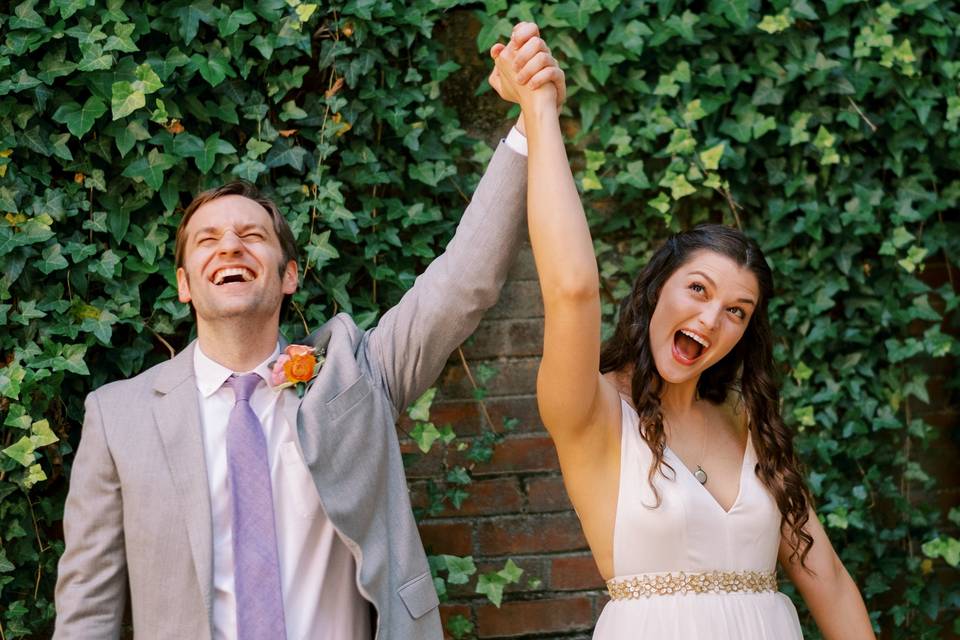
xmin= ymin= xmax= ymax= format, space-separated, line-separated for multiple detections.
xmin=54 ymin=144 xmax=526 ymax=640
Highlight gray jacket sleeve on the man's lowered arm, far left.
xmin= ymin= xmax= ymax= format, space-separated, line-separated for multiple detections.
xmin=53 ymin=393 xmax=127 ymax=640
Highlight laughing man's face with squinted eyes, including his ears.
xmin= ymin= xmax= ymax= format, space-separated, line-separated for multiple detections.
xmin=177 ymin=195 xmax=297 ymax=324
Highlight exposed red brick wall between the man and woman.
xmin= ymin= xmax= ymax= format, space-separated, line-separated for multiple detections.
xmin=400 ymin=241 xmax=606 ymax=639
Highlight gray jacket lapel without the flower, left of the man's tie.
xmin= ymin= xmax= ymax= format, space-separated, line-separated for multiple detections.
xmin=153 ymin=342 xmax=213 ymax=614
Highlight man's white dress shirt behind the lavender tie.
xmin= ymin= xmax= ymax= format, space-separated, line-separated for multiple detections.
xmin=193 ymin=344 xmax=372 ymax=640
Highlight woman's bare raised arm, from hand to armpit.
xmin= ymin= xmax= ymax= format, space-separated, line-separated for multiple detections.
xmin=492 ymin=24 xmax=618 ymax=454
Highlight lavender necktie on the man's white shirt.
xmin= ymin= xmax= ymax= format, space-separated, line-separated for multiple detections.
xmin=227 ymin=373 xmax=287 ymax=640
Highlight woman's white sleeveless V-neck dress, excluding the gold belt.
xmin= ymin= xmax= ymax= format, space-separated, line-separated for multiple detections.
xmin=593 ymin=401 xmax=803 ymax=640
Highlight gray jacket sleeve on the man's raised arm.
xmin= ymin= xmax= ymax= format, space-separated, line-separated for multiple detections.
xmin=365 ymin=143 xmax=527 ymax=412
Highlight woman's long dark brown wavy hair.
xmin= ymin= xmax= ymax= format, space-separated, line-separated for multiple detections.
xmin=600 ymin=224 xmax=813 ymax=566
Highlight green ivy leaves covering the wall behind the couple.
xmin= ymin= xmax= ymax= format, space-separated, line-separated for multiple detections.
xmin=0 ymin=0 xmax=960 ymax=639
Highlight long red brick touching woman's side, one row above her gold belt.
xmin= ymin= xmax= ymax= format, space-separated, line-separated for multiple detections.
xmin=477 ymin=513 xmax=587 ymax=556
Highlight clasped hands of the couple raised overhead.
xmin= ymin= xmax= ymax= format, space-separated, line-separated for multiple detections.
xmin=489 ymin=22 xmax=567 ymax=132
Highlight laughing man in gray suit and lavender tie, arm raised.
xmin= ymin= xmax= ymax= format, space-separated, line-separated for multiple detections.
xmin=54 ymin=24 xmax=563 ymax=640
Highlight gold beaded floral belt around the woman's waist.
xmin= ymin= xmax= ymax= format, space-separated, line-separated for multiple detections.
xmin=607 ymin=571 xmax=777 ymax=600
